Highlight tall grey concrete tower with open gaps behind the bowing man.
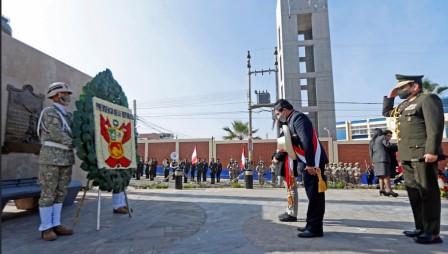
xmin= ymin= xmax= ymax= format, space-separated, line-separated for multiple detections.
xmin=276 ymin=0 xmax=336 ymax=138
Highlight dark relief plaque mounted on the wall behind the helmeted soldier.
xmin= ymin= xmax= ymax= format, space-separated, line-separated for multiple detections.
xmin=2 ymin=85 xmax=45 ymax=154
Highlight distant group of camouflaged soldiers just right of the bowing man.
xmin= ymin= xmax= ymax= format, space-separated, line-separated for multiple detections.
xmin=324 ymin=162 xmax=361 ymax=187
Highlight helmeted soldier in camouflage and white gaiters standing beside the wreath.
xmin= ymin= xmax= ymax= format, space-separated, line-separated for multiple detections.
xmin=37 ymin=82 xmax=75 ymax=241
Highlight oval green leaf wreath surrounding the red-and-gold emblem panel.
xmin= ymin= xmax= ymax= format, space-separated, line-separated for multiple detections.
xmin=73 ymin=69 xmax=137 ymax=193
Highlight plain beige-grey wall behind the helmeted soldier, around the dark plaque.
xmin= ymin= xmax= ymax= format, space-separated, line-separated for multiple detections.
xmin=1 ymin=32 xmax=92 ymax=181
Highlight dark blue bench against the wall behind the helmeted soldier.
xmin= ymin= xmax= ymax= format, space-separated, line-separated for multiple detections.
xmin=0 ymin=177 xmax=81 ymax=211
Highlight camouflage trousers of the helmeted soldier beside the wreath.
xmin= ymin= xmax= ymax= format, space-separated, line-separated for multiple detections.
xmin=39 ymin=164 xmax=72 ymax=207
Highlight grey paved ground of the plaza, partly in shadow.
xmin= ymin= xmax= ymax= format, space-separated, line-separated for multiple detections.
xmin=1 ymin=178 xmax=448 ymax=254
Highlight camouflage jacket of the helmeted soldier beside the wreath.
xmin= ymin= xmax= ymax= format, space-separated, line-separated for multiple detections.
xmin=39 ymin=105 xmax=75 ymax=166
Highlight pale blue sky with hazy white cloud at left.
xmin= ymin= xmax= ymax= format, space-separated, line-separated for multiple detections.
xmin=2 ymin=0 xmax=448 ymax=139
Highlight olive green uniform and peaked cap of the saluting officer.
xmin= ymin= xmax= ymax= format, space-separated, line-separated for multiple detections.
xmin=383 ymin=75 xmax=444 ymax=235
